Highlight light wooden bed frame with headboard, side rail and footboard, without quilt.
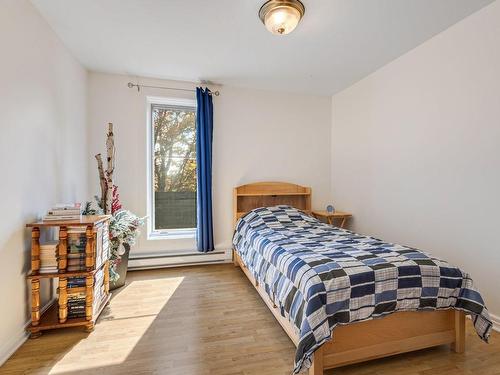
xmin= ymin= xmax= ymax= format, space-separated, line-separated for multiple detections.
xmin=233 ymin=182 xmax=465 ymax=375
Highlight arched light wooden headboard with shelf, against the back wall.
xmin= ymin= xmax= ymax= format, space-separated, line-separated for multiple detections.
xmin=233 ymin=182 xmax=311 ymax=225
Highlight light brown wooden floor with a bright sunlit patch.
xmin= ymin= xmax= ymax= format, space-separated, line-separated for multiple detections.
xmin=0 ymin=265 xmax=500 ymax=375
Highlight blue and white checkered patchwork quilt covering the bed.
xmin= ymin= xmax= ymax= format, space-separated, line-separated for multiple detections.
xmin=233 ymin=206 xmax=492 ymax=373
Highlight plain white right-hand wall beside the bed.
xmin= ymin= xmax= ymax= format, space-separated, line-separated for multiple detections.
xmin=332 ymin=1 xmax=500 ymax=324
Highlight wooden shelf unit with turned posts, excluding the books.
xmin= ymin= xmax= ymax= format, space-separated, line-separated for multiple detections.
xmin=27 ymin=215 xmax=111 ymax=338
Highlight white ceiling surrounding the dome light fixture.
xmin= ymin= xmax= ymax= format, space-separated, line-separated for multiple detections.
xmin=32 ymin=0 xmax=492 ymax=94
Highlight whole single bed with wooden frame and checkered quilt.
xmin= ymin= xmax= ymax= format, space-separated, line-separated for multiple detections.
xmin=233 ymin=182 xmax=492 ymax=375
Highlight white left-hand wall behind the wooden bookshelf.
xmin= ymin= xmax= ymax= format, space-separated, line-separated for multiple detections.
xmin=0 ymin=0 xmax=87 ymax=364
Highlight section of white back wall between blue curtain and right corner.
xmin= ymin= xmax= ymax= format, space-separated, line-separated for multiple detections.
xmin=213 ymin=87 xmax=331 ymax=247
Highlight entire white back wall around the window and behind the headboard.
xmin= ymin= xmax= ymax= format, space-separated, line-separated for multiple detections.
xmin=88 ymin=73 xmax=331 ymax=255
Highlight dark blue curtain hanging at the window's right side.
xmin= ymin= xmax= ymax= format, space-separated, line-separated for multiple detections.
xmin=196 ymin=87 xmax=214 ymax=253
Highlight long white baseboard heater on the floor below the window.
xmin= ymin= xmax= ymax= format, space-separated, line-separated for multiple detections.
xmin=128 ymin=249 xmax=232 ymax=270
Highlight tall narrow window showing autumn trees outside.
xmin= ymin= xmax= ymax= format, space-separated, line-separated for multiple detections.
xmin=148 ymin=99 xmax=196 ymax=237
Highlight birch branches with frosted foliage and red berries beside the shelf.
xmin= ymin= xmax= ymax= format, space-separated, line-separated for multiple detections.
xmin=83 ymin=123 xmax=145 ymax=281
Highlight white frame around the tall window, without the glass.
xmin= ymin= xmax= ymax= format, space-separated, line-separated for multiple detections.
xmin=146 ymin=96 xmax=197 ymax=240
